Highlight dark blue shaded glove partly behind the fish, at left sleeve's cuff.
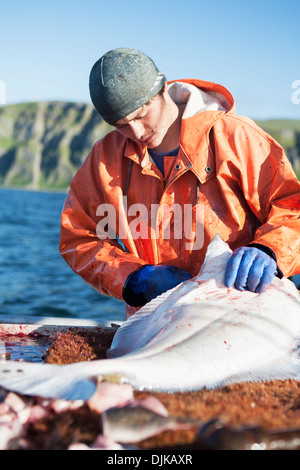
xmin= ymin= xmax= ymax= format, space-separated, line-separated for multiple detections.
xmin=123 ymin=264 xmax=193 ymax=307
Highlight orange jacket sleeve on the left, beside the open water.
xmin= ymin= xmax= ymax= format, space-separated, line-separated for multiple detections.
xmin=59 ymin=145 xmax=146 ymax=300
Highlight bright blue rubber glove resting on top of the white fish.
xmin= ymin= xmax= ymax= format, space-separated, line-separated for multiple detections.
xmin=224 ymin=246 xmax=277 ymax=293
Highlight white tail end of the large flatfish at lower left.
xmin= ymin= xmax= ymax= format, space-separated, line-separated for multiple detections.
xmin=0 ymin=361 xmax=96 ymax=400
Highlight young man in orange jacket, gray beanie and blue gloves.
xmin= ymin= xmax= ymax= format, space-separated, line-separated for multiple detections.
xmin=60 ymin=48 xmax=300 ymax=315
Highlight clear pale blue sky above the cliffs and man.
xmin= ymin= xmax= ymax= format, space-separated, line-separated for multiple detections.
xmin=0 ymin=0 xmax=300 ymax=119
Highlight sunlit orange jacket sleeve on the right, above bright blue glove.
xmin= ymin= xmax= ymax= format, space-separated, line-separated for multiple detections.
xmin=220 ymin=116 xmax=300 ymax=276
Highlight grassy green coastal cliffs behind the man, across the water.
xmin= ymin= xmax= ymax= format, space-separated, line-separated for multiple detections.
xmin=0 ymin=102 xmax=300 ymax=190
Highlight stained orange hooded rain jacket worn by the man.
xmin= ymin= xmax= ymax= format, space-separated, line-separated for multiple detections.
xmin=60 ymin=80 xmax=300 ymax=316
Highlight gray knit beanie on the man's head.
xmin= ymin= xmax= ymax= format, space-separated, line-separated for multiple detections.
xmin=89 ymin=48 xmax=166 ymax=124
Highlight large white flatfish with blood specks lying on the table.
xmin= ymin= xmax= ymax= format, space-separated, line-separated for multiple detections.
xmin=0 ymin=236 xmax=300 ymax=399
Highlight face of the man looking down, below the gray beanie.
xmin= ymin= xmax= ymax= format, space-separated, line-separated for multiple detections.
xmin=114 ymin=89 xmax=172 ymax=148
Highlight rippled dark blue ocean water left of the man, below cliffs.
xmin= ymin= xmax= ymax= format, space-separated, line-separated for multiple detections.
xmin=0 ymin=188 xmax=125 ymax=321
